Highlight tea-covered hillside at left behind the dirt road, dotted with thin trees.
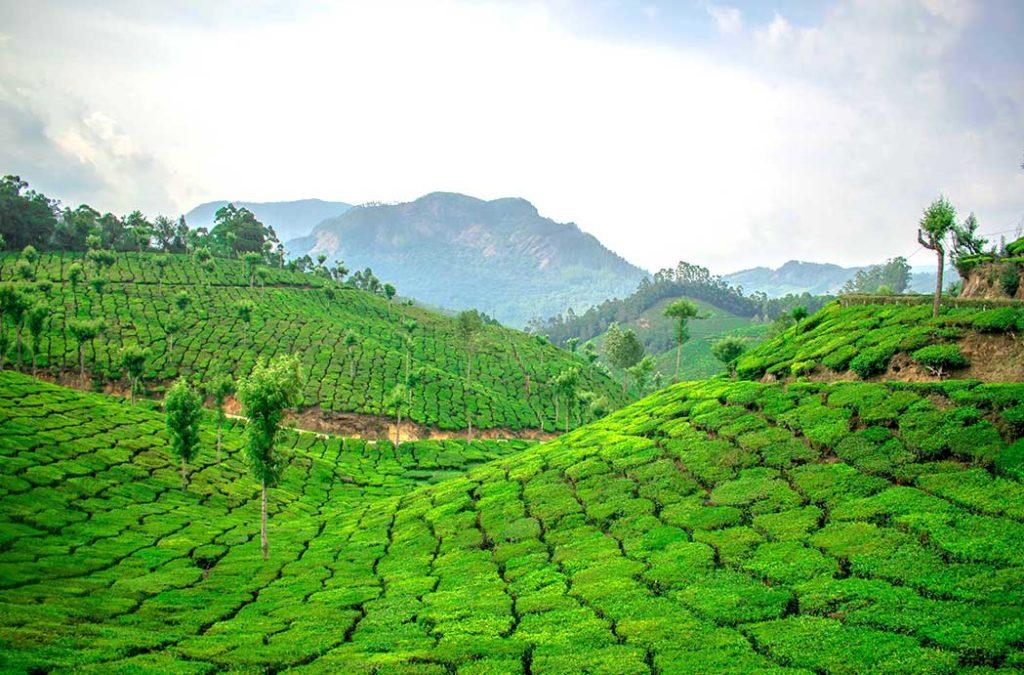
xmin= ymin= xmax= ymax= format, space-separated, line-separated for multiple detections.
xmin=0 ymin=253 xmax=622 ymax=430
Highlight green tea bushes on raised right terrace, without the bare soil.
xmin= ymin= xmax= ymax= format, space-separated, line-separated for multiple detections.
xmin=736 ymin=298 xmax=1024 ymax=379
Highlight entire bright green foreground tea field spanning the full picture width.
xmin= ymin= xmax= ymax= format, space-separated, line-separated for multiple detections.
xmin=0 ymin=373 xmax=1024 ymax=674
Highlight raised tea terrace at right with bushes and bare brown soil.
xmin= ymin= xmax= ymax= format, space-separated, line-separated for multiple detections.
xmin=736 ymin=297 xmax=1024 ymax=381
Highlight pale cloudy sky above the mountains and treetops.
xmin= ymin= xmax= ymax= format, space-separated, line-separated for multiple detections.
xmin=0 ymin=0 xmax=1024 ymax=273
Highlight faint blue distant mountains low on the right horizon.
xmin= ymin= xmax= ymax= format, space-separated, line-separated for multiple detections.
xmin=722 ymin=260 xmax=959 ymax=298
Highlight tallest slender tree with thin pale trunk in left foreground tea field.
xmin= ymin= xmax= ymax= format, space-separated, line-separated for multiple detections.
xmin=239 ymin=354 xmax=305 ymax=560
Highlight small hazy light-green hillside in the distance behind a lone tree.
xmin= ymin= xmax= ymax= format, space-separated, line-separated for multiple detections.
xmin=594 ymin=298 xmax=768 ymax=380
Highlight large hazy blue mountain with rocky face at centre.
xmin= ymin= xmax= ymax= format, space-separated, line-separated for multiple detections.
xmin=286 ymin=193 xmax=646 ymax=326
